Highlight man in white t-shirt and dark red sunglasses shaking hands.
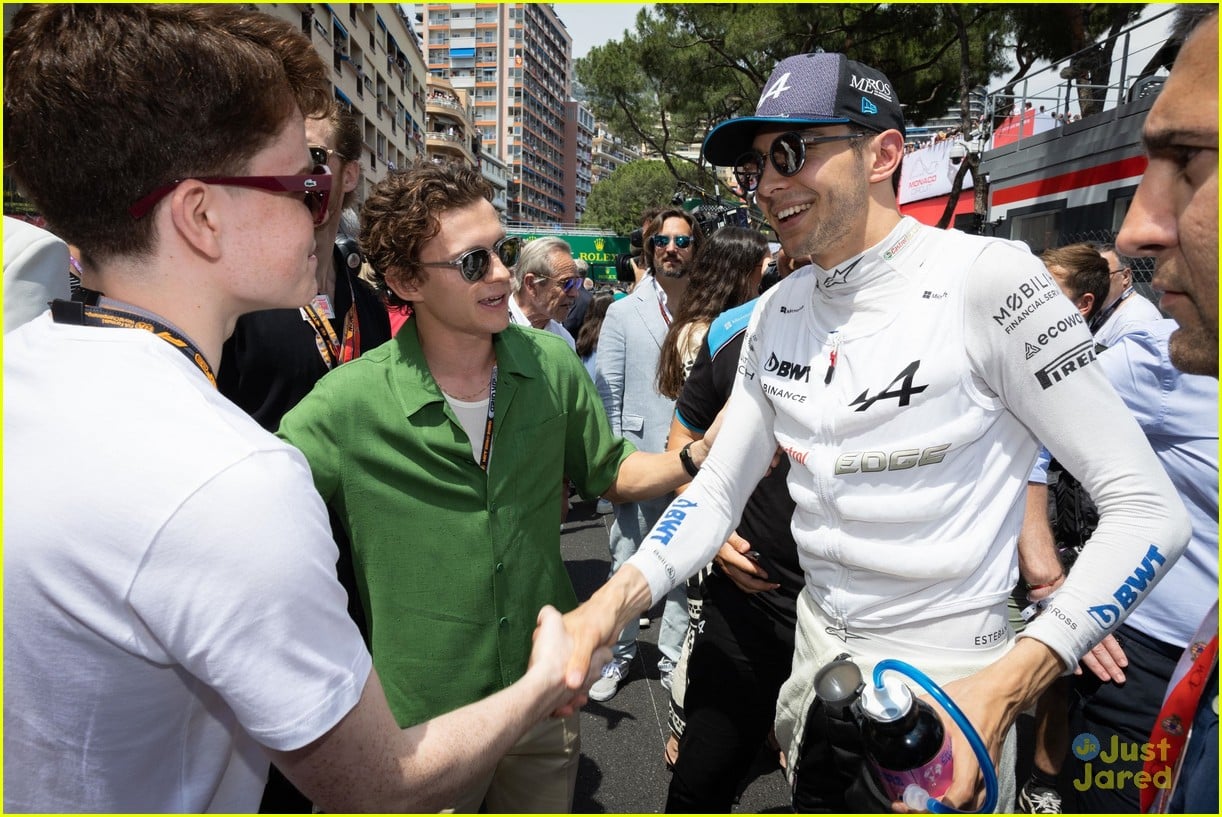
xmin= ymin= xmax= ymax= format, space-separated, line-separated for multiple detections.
xmin=4 ymin=5 xmax=601 ymax=812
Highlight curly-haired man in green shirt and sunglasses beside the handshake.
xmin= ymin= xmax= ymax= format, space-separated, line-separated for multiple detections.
xmin=280 ymin=164 xmax=708 ymax=812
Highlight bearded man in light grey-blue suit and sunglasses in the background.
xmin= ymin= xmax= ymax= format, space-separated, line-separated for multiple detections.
xmin=590 ymin=209 xmax=704 ymax=701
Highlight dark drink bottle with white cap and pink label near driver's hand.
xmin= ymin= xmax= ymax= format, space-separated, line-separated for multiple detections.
xmin=858 ymin=677 xmax=954 ymax=800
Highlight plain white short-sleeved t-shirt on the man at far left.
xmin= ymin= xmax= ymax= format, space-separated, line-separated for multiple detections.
xmin=4 ymin=314 xmax=371 ymax=812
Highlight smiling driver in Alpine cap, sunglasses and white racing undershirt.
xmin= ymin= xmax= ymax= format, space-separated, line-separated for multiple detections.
xmin=566 ymin=54 xmax=1190 ymax=811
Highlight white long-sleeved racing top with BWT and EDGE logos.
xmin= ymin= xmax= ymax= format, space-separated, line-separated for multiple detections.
xmin=629 ymin=219 xmax=1189 ymax=667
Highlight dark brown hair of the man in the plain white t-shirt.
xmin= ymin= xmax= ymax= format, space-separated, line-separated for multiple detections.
xmin=4 ymin=4 xmax=332 ymax=265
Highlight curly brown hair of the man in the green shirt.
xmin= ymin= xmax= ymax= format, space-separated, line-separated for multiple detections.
xmin=359 ymin=160 xmax=492 ymax=307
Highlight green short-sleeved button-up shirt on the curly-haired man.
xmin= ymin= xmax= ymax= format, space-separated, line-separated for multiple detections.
xmin=279 ymin=320 xmax=633 ymax=727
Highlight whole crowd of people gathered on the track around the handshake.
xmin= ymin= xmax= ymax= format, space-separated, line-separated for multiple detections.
xmin=4 ymin=4 xmax=1218 ymax=813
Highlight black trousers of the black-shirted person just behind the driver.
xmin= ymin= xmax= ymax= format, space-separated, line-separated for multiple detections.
xmin=666 ymin=570 xmax=796 ymax=813
